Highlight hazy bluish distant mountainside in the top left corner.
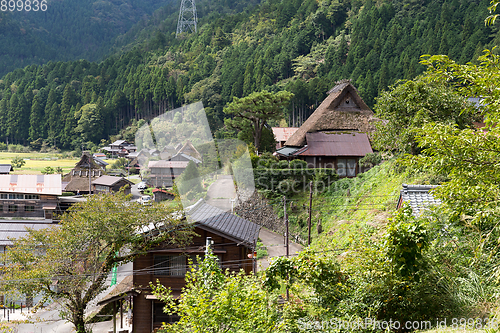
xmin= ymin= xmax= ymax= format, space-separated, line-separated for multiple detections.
xmin=0 ymin=0 xmax=178 ymax=75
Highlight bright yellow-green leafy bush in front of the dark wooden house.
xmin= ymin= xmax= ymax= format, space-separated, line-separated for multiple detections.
xmin=151 ymin=249 xmax=279 ymax=333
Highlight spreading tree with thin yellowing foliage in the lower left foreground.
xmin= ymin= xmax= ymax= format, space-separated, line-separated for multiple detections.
xmin=2 ymin=192 xmax=191 ymax=333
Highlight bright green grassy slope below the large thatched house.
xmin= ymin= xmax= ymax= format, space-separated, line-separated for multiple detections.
xmin=275 ymin=160 xmax=436 ymax=250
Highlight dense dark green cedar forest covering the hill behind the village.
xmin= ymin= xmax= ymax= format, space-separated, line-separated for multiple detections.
xmin=0 ymin=0 xmax=500 ymax=149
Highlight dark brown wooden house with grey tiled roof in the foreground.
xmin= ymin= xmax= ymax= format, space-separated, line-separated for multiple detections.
xmin=133 ymin=200 xmax=260 ymax=332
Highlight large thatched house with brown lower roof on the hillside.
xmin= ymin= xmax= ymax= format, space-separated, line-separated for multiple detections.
xmin=275 ymin=81 xmax=376 ymax=177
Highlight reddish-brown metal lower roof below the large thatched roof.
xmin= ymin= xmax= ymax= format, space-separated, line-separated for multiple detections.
xmin=298 ymin=132 xmax=373 ymax=156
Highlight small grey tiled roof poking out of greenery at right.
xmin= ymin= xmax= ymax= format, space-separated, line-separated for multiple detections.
xmin=398 ymin=184 xmax=441 ymax=217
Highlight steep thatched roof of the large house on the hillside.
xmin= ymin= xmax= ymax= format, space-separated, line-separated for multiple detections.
xmin=285 ymin=81 xmax=375 ymax=147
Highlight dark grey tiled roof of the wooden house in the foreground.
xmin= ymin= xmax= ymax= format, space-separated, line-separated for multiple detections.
xmin=186 ymin=199 xmax=260 ymax=248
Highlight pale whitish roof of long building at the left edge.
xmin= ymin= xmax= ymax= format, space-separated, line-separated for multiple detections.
xmin=0 ymin=174 xmax=62 ymax=195
